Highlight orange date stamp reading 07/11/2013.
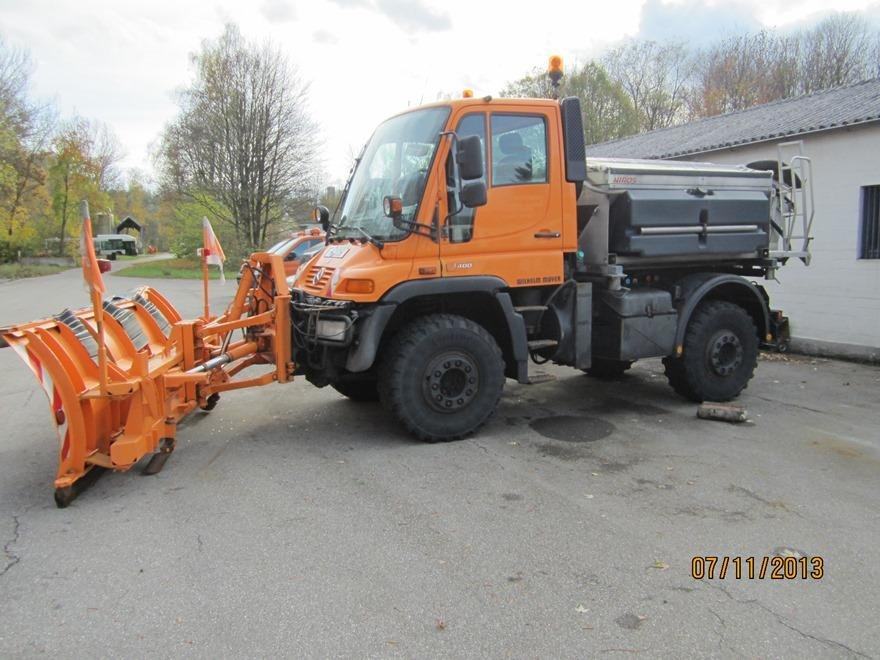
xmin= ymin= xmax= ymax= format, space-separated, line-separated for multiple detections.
xmin=691 ymin=555 xmax=825 ymax=580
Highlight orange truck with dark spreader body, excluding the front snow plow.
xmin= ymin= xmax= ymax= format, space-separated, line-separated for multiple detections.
xmin=291 ymin=97 xmax=804 ymax=441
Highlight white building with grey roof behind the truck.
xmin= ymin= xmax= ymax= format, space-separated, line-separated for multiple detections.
xmin=587 ymin=79 xmax=880 ymax=360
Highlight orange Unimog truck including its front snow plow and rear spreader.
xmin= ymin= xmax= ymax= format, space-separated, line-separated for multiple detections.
xmin=0 ymin=62 xmax=813 ymax=506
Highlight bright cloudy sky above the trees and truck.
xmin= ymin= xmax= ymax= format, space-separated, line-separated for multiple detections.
xmin=0 ymin=0 xmax=880 ymax=183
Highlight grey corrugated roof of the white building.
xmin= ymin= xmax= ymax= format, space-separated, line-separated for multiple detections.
xmin=587 ymin=78 xmax=880 ymax=158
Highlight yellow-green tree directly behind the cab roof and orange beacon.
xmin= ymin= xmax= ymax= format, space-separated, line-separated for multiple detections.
xmin=501 ymin=62 xmax=639 ymax=144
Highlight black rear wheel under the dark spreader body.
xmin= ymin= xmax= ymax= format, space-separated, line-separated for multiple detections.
xmin=663 ymin=300 xmax=758 ymax=401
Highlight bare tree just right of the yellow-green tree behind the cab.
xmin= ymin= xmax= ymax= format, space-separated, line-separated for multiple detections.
xmin=603 ymin=41 xmax=692 ymax=131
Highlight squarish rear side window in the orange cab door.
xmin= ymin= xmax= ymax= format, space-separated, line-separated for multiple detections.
xmin=492 ymin=114 xmax=547 ymax=186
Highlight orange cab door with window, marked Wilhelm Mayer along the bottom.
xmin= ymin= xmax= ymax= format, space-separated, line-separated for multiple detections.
xmin=440 ymin=104 xmax=562 ymax=287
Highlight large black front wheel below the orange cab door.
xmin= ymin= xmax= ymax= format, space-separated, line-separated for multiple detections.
xmin=379 ymin=314 xmax=504 ymax=442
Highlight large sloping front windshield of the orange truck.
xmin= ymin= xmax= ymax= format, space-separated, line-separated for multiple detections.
xmin=336 ymin=107 xmax=449 ymax=241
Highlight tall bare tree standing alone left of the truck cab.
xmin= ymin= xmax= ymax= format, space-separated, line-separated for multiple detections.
xmin=159 ymin=25 xmax=317 ymax=248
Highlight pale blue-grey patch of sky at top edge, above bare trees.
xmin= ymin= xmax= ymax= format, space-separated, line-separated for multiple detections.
xmin=635 ymin=0 xmax=762 ymax=46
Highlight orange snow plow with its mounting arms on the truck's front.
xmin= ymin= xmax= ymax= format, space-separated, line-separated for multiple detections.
xmin=0 ymin=253 xmax=294 ymax=507
